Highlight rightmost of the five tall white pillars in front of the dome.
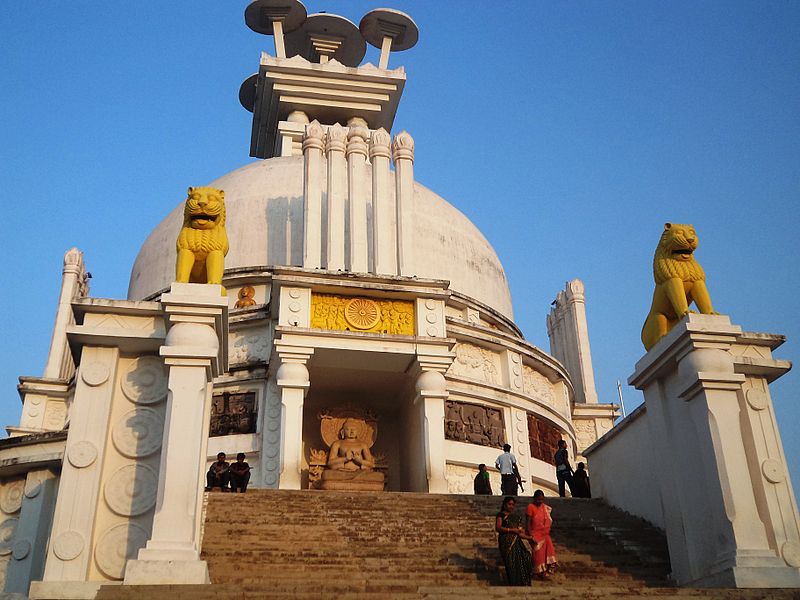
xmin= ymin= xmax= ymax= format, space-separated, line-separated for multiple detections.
xmin=392 ymin=131 xmax=414 ymax=277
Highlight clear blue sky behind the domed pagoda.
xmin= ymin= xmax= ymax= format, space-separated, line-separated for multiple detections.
xmin=0 ymin=0 xmax=800 ymax=482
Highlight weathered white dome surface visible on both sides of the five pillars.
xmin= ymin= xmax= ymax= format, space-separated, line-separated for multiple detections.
xmin=128 ymin=156 xmax=513 ymax=319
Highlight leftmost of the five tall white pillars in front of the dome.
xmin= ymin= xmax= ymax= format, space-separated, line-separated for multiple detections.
xmin=303 ymin=120 xmax=324 ymax=269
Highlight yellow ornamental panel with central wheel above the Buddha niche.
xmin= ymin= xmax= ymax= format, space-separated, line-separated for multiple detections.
xmin=311 ymin=294 xmax=415 ymax=335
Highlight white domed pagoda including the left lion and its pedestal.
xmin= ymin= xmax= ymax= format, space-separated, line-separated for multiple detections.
xmin=0 ymin=0 xmax=797 ymax=598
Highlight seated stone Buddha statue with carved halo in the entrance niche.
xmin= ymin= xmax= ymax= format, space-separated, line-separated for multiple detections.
xmin=309 ymin=409 xmax=385 ymax=491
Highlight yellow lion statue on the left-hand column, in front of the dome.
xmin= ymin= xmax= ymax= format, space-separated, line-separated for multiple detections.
xmin=175 ymin=187 xmax=228 ymax=296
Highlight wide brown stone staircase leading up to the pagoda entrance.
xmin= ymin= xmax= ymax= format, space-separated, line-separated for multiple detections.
xmin=97 ymin=490 xmax=797 ymax=600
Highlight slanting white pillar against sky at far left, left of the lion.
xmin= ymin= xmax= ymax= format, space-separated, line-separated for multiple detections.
xmin=44 ymin=248 xmax=89 ymax=379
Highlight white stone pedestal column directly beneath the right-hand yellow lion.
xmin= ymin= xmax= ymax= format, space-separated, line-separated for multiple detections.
xmin=629 ymin=314 xmax=800 ymax=587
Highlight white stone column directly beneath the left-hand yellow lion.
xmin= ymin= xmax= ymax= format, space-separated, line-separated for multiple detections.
xmin=125 ymin=283 xmax=228 ymax=585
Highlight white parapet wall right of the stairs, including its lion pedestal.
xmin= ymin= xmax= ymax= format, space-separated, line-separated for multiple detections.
xmin=586 ymin=314 xmax=800 ymax=588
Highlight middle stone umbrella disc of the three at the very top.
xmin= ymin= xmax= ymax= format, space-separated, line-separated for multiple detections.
xmin=284 ymin=13 xmax=367 ymax=67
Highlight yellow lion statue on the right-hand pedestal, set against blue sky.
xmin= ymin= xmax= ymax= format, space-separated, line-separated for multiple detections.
xmin=642 ymin=223 xmax=717 ymax=350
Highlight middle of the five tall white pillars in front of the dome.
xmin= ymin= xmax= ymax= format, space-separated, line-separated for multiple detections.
xmin=347 ymin=119 xmax=369 ymax=273
